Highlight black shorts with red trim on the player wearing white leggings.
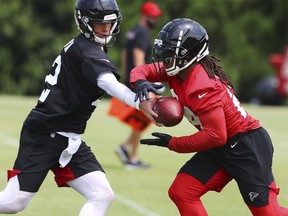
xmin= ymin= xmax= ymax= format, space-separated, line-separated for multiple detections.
xmin=13 ymin=126 xmax=104 ymax=192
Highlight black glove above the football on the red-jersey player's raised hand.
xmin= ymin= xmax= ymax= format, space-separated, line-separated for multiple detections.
xmin=134 ymin=80 xmax=164 ymax=102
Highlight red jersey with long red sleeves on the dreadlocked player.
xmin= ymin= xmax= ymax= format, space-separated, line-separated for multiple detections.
xmin=130 ymin=64 xmax=260 ymax=152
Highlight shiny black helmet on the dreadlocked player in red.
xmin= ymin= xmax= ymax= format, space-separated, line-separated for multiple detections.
xmin=152 ymin=18 xmax=209 ymax=76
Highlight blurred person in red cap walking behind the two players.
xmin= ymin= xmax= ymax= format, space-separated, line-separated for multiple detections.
xmin=108 ymin=1 xmax=165 ymax=169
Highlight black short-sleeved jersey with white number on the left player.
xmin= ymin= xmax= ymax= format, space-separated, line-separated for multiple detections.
xmin=24 ymin=34 xmax=120 ymax=134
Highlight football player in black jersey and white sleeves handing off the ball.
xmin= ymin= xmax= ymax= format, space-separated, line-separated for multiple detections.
xmin=0 ymin=0 xmax=161 ymax=216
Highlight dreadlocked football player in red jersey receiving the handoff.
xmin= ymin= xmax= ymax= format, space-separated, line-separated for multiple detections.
xmin=130 ymin=18 xmax=288 ymax=216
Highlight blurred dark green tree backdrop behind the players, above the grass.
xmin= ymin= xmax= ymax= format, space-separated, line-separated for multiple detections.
xmin=0 ymin=0 xmax=288 ymax=105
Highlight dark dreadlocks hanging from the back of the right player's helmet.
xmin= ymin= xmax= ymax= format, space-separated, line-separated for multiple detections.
xmin=199 ymin=55 xmax=235 ymax=89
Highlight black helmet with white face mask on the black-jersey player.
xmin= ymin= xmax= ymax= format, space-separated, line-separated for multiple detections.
xmin=74 ymin=0 xmax=122 ymax=47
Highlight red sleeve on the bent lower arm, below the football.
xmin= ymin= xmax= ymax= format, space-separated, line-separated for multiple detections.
xmin=168 ymin=107 xmax=227 ymax=153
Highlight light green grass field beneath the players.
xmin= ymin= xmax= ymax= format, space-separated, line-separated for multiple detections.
xmin=0 ymin=96 xmax=288 ymax=216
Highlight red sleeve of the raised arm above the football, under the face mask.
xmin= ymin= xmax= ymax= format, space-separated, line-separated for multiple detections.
xmin=130 ymin=64 xmax=167 ymax=87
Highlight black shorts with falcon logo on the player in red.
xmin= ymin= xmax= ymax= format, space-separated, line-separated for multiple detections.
xmin=179 ymin=128 xmax=274 ymax=207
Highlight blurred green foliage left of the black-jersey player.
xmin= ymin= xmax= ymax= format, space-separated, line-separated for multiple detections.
xmin=0 ymin=0 xmax=75 ymax=95
